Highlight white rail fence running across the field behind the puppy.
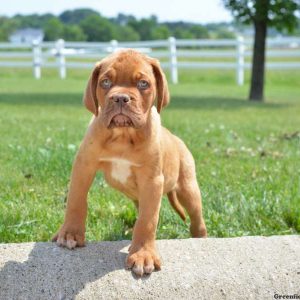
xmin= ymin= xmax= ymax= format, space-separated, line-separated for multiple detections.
xmin=0 ymin=37 xmax=300 ymax=85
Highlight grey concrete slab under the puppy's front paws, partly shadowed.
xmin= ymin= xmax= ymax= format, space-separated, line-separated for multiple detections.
xmin=0 ymin=236 xmax=300 ymax=300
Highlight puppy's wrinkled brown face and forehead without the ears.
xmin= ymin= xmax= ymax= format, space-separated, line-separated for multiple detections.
xmin=96 ymin=53 xmax=156 ymax=128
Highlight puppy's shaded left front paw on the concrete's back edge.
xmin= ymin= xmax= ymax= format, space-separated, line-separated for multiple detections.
xmin=52 ymin=224 xmax=85 ymax=249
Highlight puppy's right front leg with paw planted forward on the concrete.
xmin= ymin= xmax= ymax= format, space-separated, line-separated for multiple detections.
xmin=126 ymin=174 xmax=163 ymax=276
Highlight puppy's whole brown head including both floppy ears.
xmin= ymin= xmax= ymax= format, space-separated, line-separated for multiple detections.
xmin=84 ymin=50 xmax=168 ymax=129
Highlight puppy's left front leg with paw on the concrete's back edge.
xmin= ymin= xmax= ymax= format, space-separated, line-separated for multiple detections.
xmin=52 ymin=153 xmax=96 ymax=249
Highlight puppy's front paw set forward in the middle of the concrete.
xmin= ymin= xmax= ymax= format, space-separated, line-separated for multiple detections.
xmin=126 ymin=247 xmax=161 ymax=276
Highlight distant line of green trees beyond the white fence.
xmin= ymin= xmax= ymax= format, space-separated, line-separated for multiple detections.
xmin=0 ymin=9 xmax=239 ymax=41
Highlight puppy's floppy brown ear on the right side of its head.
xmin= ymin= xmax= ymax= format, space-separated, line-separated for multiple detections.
xmin=150 ymin=58 xmax=170 ymax=113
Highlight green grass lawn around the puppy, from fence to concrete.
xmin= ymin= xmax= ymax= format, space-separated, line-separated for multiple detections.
xmin=0 ymin=69 xmax=300 ymax=242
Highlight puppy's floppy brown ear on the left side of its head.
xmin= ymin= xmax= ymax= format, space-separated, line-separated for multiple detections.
xmin=83 ymin=63 xmax=101 ymax=116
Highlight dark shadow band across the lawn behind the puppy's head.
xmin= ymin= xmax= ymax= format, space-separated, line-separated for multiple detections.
xmin=0 ymin=93 xmax=289 ymax=110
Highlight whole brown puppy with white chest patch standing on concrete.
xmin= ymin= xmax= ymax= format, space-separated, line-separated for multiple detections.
xmin=53 ymin=50 xmax=206 ymax=276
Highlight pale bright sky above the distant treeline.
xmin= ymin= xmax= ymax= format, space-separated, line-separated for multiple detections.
xmin=0 ymin=0 xmax=232 ymax=24
